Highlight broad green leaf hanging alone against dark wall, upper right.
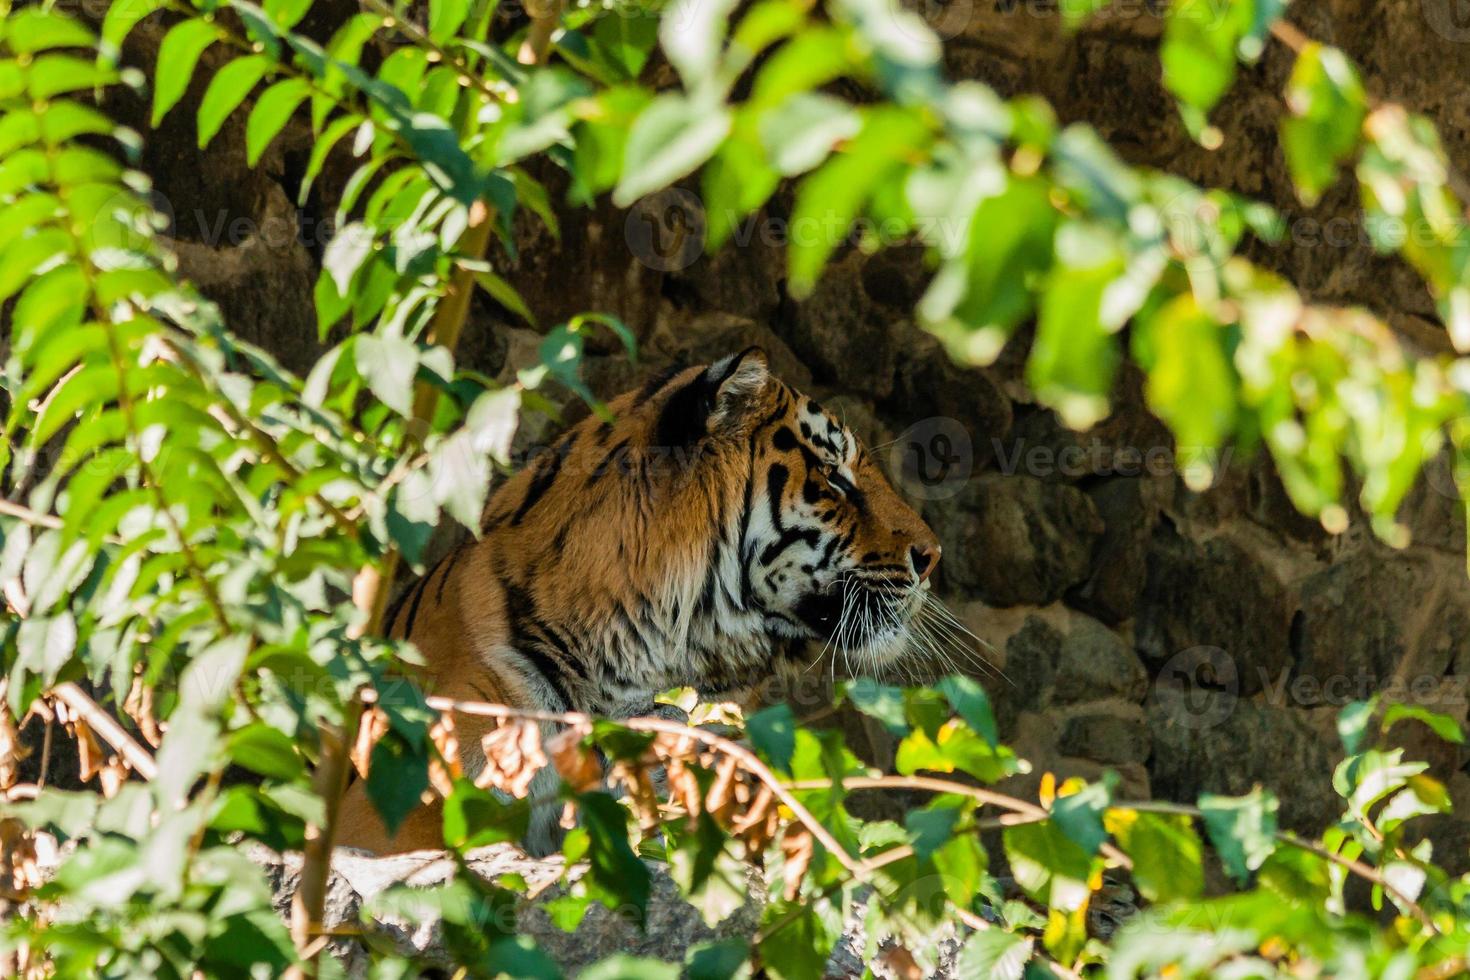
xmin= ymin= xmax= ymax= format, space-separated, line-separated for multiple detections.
xmin=1282 ymin=43 xmax=1367 ymax=206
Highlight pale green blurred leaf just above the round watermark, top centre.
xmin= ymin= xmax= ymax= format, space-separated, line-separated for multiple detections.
xmin=613 ymin=92 xmax=731 ymax=207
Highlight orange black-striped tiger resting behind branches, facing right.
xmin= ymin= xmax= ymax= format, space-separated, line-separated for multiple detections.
xmin=338 ymin=347 xmax=941 ymax=852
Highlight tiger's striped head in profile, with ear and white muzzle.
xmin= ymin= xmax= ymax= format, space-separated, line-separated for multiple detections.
xmin=643 ymin=348 xmax=939 ymax=671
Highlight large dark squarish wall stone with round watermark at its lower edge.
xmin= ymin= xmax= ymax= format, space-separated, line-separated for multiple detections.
xmin=1136 ymin=522 xmax=1295 ymax=695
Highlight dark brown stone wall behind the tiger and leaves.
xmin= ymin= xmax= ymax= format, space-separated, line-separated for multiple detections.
xmin=103 ymin=0 xmax=1470 ymax=868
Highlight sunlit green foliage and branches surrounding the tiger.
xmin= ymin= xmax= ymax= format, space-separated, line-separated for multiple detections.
xmin=0 ymin=0 xmax=1470 ymax=977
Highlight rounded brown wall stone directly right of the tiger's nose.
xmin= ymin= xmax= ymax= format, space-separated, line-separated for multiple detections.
xmin=925 ymin=473 xmax=1103 ymax=605
